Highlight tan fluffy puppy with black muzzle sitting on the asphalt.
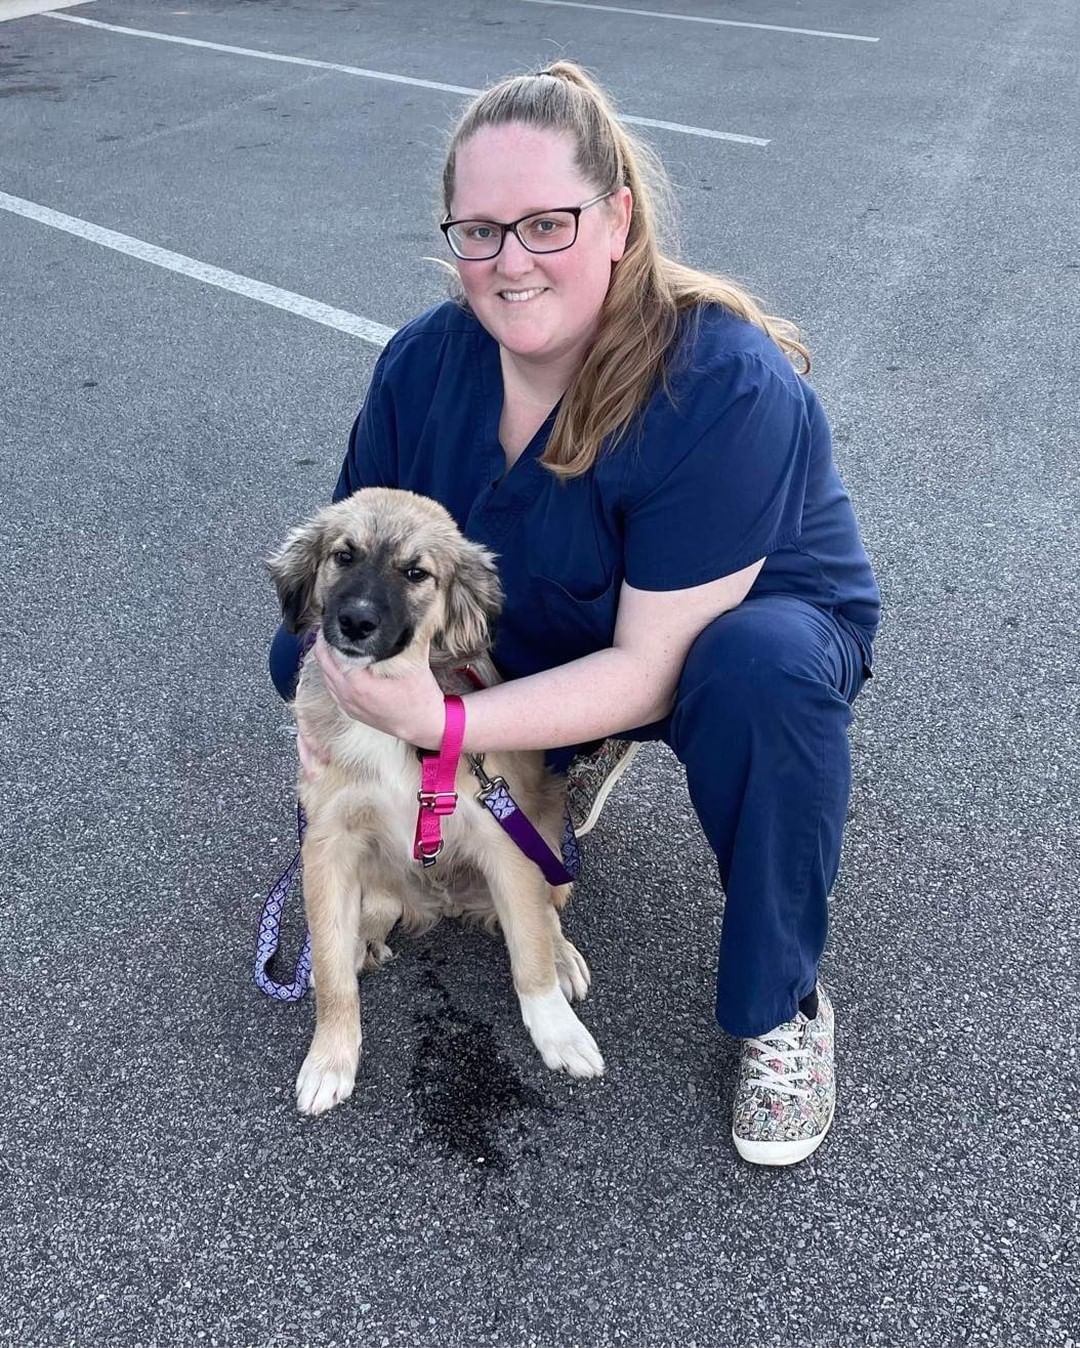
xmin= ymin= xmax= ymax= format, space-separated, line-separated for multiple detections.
xmin=266 ymin=488 xmax=604 ymax=1115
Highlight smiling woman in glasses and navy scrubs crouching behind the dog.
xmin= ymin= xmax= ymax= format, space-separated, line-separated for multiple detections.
xmin=271 ymin=62 xmax=879 ymax=1165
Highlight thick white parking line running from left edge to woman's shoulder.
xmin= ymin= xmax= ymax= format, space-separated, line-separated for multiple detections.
xmin=0 ymin=191 xmax=394 ymax=348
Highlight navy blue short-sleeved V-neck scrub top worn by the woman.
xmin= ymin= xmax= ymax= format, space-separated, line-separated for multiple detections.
xmin=326 ymin=302 xmax=880 ymax=678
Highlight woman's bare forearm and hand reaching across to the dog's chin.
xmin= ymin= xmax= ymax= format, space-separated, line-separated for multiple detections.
xmin=316 ymin=558 xmax=764 ymax=754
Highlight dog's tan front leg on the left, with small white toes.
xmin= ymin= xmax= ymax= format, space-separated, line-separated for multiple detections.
xmin=297 ymin=821 xmax=360 ymax=1113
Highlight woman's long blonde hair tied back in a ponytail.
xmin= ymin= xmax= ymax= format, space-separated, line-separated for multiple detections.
xmin=442 ymin=61 xmax=810 ymax=477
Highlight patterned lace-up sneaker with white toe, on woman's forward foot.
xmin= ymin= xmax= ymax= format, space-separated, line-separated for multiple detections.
xmin=731 ymin=984 xmax=836 ymax=1166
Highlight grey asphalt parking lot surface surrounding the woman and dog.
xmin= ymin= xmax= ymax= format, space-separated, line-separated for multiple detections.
xmin=0 ymin=0 xmax=1080 ymax=1348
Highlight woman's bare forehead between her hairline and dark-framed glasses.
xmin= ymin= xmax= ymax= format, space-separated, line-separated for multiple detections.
xmin=450 ymin=123 xmax=589 ymax=220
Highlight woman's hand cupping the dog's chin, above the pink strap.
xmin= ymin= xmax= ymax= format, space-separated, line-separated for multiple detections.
xmin=314 ymin=632 xmax=446 ymax=749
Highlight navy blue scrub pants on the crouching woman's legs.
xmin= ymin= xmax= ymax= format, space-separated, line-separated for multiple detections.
xmin=271 ymin=594 xmax=867 ymax=1037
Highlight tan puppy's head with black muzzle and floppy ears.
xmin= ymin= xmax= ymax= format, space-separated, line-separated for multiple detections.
xmin=267 ymin=487 xmax=502 ymax=665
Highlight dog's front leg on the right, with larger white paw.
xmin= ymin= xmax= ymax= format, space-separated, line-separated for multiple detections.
xmin=481 ymin=840 xmax=604 ymax=1077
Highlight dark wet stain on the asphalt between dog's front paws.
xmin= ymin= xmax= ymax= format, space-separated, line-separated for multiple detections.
xmin=409 ymin=954 xmax=557 ymax=1174
